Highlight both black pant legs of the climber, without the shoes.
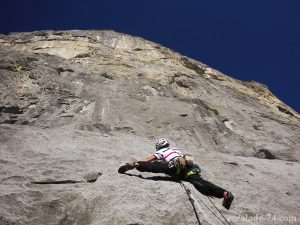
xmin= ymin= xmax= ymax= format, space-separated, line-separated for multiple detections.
xmin=136 ymin=161 xmax=225 ymax=198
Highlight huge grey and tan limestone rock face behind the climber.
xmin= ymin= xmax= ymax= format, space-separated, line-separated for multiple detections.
xmin=0 ymin=30 xmax=300 ymax=225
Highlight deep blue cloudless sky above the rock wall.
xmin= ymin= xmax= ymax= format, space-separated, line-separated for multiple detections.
xmin=0 ymin=0 xmax=300 ymax=112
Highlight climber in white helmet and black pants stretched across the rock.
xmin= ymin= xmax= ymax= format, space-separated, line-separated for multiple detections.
xmin=118 ymin=138 xmax=234 ymax=209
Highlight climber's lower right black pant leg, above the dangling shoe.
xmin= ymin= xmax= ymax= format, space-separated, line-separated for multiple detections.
xmin=185 ymin=174 xmax=226 ymax=198
